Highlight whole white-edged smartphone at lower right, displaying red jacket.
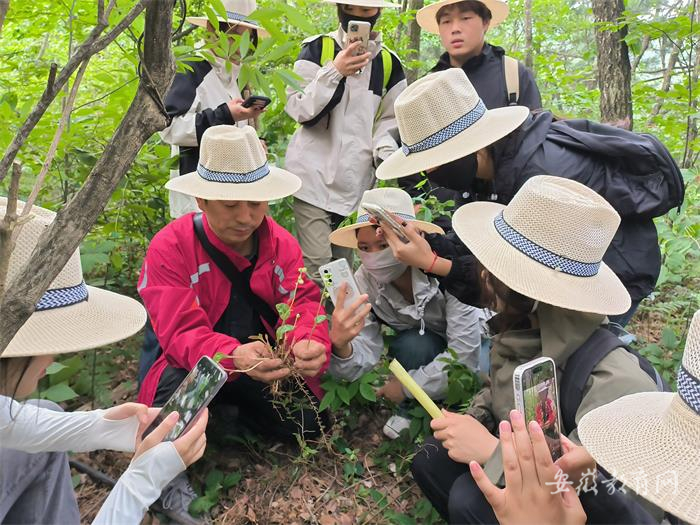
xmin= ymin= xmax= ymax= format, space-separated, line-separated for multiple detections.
xmin=513 ymin=357 xmax=563 ymax=461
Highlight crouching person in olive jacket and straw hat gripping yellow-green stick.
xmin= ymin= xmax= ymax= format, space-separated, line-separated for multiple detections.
xmin=396 ymin=175 xmax=658 ymax=523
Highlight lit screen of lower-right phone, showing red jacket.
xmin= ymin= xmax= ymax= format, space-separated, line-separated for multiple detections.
xmin=522 ymin=361 xmax=562 ymax=460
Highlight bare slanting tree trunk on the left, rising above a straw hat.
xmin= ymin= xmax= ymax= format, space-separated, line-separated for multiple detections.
xmin=0 ymin=0 xmax=175 ymax=354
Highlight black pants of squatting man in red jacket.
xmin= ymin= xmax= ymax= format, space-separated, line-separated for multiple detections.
xmin=153 ymin=365 xmax=327 ymax=442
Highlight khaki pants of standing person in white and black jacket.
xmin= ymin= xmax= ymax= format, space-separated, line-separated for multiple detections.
xmin=292 ymin=198 xmax=353 ymax=288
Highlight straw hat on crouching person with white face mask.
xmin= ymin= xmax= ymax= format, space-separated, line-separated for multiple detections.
xmin=328 ymin=188 xmax=445 ymax=248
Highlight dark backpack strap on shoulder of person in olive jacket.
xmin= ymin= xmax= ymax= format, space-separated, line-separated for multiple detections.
xmin=559 ymin=327 xmax=671 ymax=435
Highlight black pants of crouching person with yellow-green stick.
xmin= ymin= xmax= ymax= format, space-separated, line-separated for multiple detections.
xmin=411 ymin=437 xmax=498 ymax=525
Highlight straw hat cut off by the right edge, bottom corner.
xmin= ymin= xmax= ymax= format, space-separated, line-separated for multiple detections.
xmin=578 ymin=311 xmax=700 ymax=524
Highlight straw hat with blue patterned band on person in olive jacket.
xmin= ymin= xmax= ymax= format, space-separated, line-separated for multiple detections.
xmin=452 ymin=175 xmax=630 ymax=315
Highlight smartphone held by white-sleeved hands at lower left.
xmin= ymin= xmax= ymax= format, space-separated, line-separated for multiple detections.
xmin=144 ymin=356 xmax=228 ymax=441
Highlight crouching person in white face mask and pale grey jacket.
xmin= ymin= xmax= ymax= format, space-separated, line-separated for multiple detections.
xmin=329 ymin=188 xmax=486 ymax=439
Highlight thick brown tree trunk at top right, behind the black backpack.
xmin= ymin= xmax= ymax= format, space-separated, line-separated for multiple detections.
xmin=592 ymin=0 xmax=632 ymax=129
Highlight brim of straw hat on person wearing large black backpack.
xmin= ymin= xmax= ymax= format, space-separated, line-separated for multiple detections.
xmin=376 ymin=106 xmax=530 ymax=180
